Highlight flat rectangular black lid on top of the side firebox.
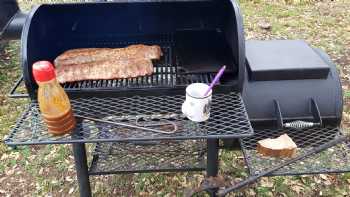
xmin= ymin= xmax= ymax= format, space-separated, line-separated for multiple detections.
xmin=246 ymin=40 xmax=329 ymax=81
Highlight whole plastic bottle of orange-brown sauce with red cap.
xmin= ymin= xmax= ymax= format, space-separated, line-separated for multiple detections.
xmin=33 ymin=61 xmax=76 ymax=135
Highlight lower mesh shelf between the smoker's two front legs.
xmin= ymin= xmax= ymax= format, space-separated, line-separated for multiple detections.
xmin=89 ymin=140 xmax=206 ymax=175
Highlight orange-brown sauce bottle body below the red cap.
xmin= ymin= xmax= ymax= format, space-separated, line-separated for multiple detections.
xmin=37 ymin=78 xmax=76 ymax=135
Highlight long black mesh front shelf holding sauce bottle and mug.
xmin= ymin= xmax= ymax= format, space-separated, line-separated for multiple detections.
xmin=6 ymin=92 xmax=253 ymax=145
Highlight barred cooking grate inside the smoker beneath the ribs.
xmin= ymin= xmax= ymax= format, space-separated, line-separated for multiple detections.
xmin=63 ymin=35 xmax=220 ymax=91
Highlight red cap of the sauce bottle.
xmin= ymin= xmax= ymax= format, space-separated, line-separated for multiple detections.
xmin=33 ymin=61 xmax=56 ymax=82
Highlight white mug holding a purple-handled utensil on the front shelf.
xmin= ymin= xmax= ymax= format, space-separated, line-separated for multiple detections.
xmin=182 ymin=83 xmax=212 ymax=122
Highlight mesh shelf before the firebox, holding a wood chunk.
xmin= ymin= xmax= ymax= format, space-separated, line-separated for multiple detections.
xmin=240 ymin=127 xmax=350 ymax=176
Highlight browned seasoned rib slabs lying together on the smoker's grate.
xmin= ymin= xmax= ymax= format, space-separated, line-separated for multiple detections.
xmin=55 ymin=44 xmax=162 ymax=83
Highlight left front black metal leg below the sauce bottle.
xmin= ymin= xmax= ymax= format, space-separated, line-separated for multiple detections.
xmin=73 ymin=143 xmax=91 ymax=197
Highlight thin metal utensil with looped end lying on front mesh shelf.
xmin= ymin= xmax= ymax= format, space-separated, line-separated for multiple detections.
xmin=75 ymin=115 xmax=178 ymax=134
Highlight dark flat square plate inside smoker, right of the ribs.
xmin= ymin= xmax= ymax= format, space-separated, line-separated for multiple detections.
xmin=176 ymin=31 xmax=238 ymax=74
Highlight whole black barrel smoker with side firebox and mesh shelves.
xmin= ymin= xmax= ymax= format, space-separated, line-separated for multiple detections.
xmin=0 ymin=0 xmax=350 ymax=196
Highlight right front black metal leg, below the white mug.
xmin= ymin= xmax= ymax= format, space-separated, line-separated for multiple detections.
xmin=207 ymin=139 xmax=219 ymax=197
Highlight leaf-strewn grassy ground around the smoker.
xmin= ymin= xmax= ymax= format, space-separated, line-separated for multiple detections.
xmin=0 ymin=0 xmax=350 ymax=196
